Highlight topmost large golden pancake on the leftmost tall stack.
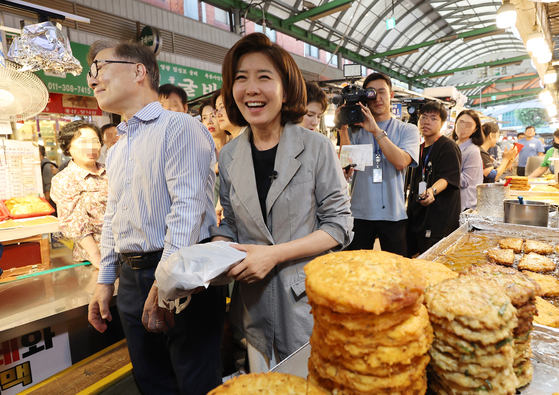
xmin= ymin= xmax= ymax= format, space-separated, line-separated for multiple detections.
xmin=305 ymin=250 xmax=425 ymax=314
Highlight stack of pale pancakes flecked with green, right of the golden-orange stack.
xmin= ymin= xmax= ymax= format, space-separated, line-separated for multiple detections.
xmin=425 ymin=276 xmax=518 ymax=395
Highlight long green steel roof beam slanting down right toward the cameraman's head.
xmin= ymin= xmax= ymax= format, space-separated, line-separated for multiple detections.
xmin=206 ymin=0 xmax=426 ymax=88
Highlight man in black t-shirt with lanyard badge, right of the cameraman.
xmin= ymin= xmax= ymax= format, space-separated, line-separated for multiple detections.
xmin=407 ymin=101 xmax=462 ymax=258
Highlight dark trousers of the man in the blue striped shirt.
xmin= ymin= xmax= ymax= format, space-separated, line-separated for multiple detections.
xmin=117 ymin=263 xmax=225 ymax=395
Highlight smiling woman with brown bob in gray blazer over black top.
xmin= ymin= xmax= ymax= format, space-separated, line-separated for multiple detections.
xmin=211 ymin=33 xmax=353 ymax=372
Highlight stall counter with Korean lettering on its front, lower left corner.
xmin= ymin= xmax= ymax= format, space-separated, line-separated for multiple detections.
xmin=0 ymin=243 xmax=124 ymax=395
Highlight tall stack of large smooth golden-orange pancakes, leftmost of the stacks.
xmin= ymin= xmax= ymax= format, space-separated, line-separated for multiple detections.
xmin=305 ymin=250 xmax=433 ymax=395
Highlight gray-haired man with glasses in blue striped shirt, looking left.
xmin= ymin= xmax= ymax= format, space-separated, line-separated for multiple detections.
xmin=88 ymin=41 xmax=225 ymax=395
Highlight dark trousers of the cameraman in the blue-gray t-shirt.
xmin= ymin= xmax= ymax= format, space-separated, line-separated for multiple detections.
xmin=347 ymin=219 xmax=407 ymax=256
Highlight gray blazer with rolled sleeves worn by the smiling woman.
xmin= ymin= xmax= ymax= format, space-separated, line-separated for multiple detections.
xmin=210 ymin=123 xmax=353 ymax=359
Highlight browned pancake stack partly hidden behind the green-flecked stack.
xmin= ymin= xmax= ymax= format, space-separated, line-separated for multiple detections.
xmin=461 ymin=264 xmax=541 ymax=387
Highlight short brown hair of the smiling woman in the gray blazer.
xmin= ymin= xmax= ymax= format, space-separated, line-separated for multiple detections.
xmin=221 ymin=33 xmax=307 ymax=126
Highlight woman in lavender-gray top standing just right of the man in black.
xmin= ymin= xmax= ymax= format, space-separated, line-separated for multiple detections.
xmin=452 ymin=110 xmax=483 ymax=211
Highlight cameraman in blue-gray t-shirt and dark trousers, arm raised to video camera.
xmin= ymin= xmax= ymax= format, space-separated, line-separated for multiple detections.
xmin=340 ymin=73 xmax=419 ymax=256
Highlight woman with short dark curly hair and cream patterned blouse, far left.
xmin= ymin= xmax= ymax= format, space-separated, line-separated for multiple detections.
xmin=51 ymin=121 xmax=109 ymax=268
